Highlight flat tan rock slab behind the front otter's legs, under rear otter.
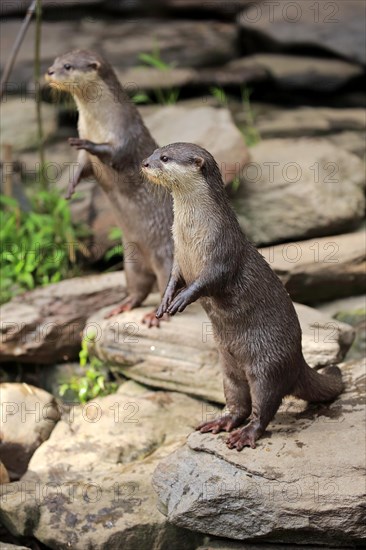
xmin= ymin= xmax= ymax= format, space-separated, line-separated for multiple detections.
xmin=88 ymin=296 xmax=354 ymax=403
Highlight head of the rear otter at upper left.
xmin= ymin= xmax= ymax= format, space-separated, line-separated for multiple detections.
xmin=45 ymin=50 xmax=103 ymax=96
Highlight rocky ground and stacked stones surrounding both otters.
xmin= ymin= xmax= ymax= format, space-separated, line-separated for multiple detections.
xmin=0 ymin=0 xmax=366 ymax=550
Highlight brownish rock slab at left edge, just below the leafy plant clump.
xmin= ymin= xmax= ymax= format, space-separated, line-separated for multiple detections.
xmin=0 ymin=272 xmax=126 ymax=364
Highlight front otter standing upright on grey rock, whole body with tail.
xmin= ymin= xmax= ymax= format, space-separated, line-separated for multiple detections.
xmin=142 ymin=143 xmax=343 ymax=451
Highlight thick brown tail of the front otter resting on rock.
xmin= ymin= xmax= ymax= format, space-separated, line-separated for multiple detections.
xmin=292 ymin=360 xmax=344 ymax=402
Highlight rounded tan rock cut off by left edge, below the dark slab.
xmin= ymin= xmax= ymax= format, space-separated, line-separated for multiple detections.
xmin=0 ymin=383 xmax=60 ymax=480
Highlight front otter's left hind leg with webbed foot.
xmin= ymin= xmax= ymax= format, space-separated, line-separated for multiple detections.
xmin=196 ymin=350 xmax=252 ymax=434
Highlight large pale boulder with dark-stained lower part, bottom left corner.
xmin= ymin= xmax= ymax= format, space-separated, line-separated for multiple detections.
xmin=0 ymin=382 xmax=212 ymax=550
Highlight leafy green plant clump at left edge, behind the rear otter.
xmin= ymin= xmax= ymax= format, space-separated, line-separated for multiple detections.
xmin=0 ymin=191 xmax=85 ymax=303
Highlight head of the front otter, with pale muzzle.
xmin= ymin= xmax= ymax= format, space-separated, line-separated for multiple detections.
xmin=141 ymin=143 xmax=214 ymax=194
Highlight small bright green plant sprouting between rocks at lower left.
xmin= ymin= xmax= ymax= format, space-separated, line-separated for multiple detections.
xmin=59 ymin=333 xmax=117 ymax=403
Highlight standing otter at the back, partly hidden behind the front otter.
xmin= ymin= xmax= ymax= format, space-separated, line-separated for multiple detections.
xmin=46 ymin=50 xmax=173 ymax=326
